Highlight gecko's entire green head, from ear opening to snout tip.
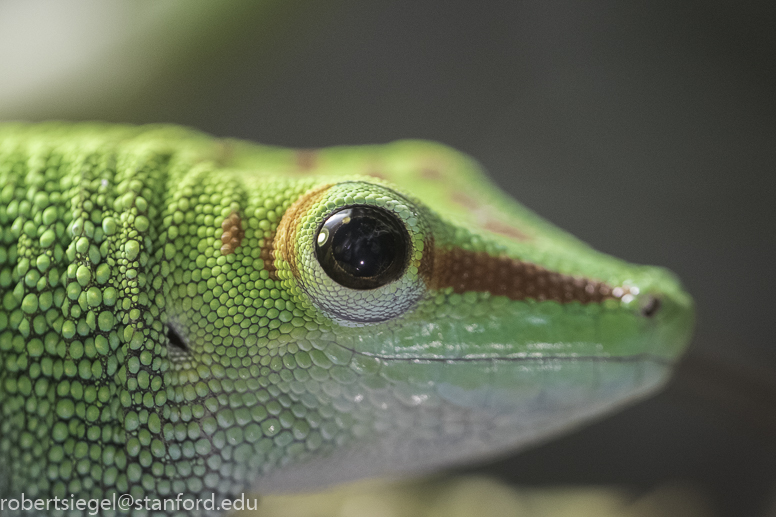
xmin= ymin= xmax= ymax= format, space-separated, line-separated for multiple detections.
xmin=160 ymin=142 xmax=693 ymax=492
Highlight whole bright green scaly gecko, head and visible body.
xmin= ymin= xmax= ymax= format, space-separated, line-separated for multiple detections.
xmin=0 ymin=123 xmax=693 ymax=515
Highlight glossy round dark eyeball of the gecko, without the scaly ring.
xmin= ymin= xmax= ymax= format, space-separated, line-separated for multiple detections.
xmin=315 ymin=206 xmax=410 ymax=289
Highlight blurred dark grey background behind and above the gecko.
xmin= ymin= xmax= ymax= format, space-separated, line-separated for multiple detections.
xmin=0 ymin=0 xmax=776 ymax=516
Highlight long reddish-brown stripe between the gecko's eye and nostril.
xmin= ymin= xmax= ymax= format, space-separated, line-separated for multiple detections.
xmin=430 ymin=248 xmax=627 ymax=303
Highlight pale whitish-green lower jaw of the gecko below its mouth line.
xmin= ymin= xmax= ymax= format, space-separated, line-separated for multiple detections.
xmin=254 ymin=355 xmax=670 ymax=493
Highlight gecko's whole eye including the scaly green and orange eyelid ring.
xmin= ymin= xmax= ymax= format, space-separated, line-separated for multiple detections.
xmin=286 ymin=181 xmax=433 ymax=327
